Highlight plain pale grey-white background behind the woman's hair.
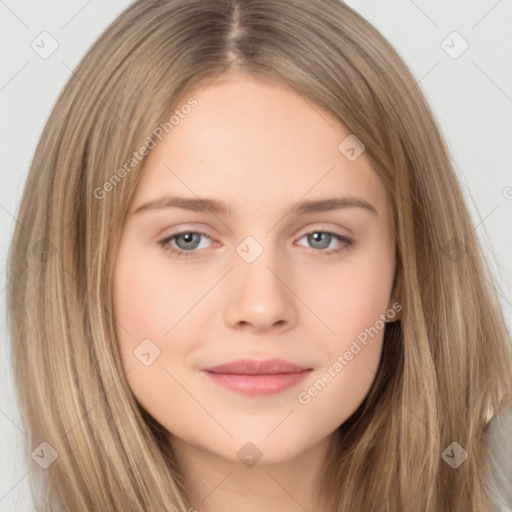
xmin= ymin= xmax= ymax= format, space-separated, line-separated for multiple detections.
xmin=0 ymin=0 xmax=512 ymax=512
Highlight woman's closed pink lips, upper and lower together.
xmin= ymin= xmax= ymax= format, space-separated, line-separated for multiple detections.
xmin=203 ymin=359 xmax=312 ymax=396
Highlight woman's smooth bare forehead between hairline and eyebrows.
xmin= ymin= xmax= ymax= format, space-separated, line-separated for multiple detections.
xmin=130 ymin=73 xmax=387 ymax=218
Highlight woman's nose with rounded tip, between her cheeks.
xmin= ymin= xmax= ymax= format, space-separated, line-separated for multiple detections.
xmin=224 ymin=251 xmax=300 ymax=332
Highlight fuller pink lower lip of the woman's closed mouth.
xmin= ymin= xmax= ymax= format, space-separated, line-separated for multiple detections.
xmin=204 ymin=370 xmax=311 ymax=396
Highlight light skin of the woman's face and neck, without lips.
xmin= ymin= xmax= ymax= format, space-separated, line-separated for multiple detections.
xmin=114 ymin=72 xmax=399 ymax=512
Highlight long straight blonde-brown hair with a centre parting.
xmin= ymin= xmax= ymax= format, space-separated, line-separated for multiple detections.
xmin=8 ymin=0 xmax=512 ymax=512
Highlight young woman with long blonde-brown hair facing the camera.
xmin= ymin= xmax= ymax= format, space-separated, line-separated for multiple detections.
xmin=9 ymin=0 xmax=512 ymax=512
